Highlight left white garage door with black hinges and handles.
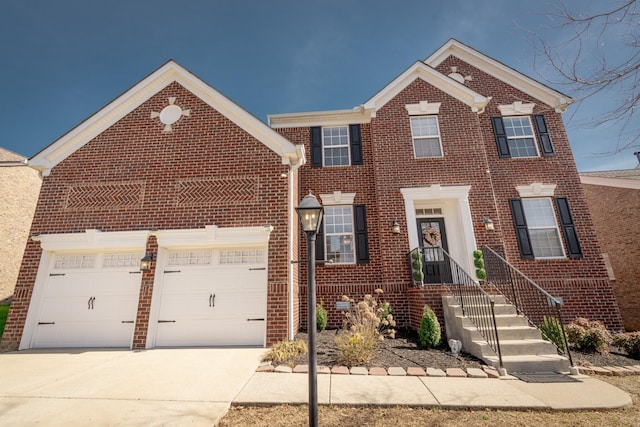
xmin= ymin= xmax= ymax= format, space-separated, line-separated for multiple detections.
xmin=33 ymin=253 xmax=143 ymax=348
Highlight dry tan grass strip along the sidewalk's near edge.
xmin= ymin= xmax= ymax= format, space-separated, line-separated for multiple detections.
xmin=219 ymin=374 xmax=640 ymax=427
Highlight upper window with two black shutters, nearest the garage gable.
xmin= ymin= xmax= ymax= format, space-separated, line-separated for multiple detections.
xmin=310 ymin=124 xmax=363 ymax=167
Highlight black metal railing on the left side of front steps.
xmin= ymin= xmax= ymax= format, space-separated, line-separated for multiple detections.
xmin=408 ymin=247 xmax=503 ymax=368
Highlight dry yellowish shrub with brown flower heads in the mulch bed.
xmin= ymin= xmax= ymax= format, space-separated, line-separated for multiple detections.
xmin=335 ymin=289 xmax=396 ymax=366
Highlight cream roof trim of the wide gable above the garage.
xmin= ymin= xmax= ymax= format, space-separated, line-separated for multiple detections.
xmin=28 ymin=60 xmax=304 ymax=176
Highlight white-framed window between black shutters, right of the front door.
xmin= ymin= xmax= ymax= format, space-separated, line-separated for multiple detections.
xmin=522 ymin=198 xmax=564 ymax=258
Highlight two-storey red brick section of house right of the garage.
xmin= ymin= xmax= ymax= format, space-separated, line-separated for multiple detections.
xmin=269 ymin=40 xmax=621 ymax=330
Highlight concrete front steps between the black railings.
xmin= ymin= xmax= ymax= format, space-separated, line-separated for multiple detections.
xmin=442 ymin=295 xmax=569 ymax=372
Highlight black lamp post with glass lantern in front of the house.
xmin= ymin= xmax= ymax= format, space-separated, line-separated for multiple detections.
xmin=296 ymin=193 xmax=324 ymax=426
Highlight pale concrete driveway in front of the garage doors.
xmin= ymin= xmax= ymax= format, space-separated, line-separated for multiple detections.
xmin=0 ymin=348 xmax=265 ymax=426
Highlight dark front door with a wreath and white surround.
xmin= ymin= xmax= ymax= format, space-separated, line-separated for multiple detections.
xmin=418 ymin=218 xmax=451 ymax=283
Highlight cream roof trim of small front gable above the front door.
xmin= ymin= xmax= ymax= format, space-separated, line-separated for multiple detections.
xmin=363 ymin=61 xmax=491 ymax=113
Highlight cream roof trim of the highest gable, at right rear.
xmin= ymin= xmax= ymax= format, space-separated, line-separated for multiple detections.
xmin=424 ymin=39 xmax=573 ymax=113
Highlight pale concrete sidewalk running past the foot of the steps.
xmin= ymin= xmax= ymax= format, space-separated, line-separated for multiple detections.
xmin=232 ymin=372 xmax=632 ymax=410
